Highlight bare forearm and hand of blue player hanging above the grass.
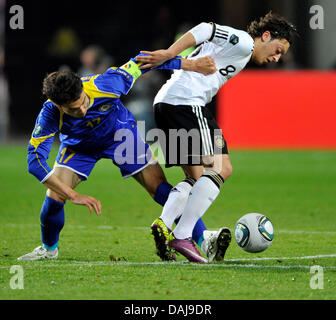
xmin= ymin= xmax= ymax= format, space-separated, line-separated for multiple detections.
xmin=43 ymin=174 xmax=101 ymax=215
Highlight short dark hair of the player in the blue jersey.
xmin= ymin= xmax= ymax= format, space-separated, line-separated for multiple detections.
xmin=42 ymin=70 xmax=83 ymax=106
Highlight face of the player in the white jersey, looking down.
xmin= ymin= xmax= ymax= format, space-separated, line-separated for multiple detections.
xmin=252 ymin=31 xmax=290 ymax=64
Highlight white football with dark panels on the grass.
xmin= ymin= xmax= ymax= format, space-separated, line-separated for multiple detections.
xmin=234 ymin=213 xmax=274 ymax=252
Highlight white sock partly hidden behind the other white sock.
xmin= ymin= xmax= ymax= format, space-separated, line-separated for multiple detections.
xmin=160 ymin=178 xmax=195 ymax=229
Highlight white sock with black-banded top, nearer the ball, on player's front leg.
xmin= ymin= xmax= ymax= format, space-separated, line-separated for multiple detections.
xmin=173 ymin=171 xmax=224 ymax=239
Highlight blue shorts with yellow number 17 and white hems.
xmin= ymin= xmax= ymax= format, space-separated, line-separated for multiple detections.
xmin=54 ymin=121 xmax=152 ymax=180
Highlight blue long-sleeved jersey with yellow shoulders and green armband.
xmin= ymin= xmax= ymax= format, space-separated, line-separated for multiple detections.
xmin=27 ymin=57 xmax=181 ymax=182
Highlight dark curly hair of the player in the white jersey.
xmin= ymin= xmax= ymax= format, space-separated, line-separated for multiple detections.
xmin=247 ymin=11 xmax=298 ymax=44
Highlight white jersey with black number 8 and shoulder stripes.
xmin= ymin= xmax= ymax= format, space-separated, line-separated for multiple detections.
xmin=154 ymin=23 xmax=254 ymax=106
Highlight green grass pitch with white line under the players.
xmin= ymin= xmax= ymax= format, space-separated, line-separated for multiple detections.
xmin=0 ymin=145 xmax=336 ymax=300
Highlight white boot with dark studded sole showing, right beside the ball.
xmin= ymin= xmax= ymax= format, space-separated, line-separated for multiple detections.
xmin=201 ymin=228 xmax=231 ymax=262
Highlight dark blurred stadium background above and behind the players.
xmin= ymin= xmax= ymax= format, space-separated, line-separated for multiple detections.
xmin=4 ymin=0 xmax=311 ymax=136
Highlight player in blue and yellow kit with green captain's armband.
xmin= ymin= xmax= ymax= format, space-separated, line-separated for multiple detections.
xmin=18 ymin=52 xmax=220 ymax=260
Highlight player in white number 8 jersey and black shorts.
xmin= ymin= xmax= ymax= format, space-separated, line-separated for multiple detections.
xmin=137 ymin=12 xmax=296 ymax=263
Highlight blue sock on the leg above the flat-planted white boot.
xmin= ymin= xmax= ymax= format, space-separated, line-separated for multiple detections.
xmin=40 ymin=196 xmax=64 ymax=250
